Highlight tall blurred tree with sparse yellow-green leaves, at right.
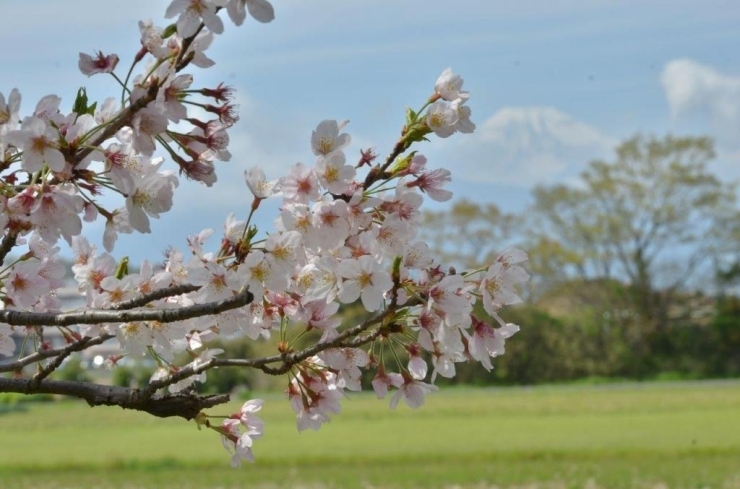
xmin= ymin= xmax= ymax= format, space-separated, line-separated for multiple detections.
xmin=529 ymin=135 xmax=740 ymax=370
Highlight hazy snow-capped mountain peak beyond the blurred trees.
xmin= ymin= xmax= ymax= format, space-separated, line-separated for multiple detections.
xmin=436 ymin=107 xmax=616 ymax=187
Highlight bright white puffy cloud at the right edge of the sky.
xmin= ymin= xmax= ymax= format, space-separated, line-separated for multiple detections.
xmin=660 ymin=59 xmax=740 ymax=140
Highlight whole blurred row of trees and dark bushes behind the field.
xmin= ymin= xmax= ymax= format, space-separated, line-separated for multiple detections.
xmin=422 ymin=135 xmax=740 ymax=383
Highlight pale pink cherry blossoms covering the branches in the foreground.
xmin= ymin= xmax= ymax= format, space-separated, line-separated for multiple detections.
xmin=0 ymin=0 xmax=528 ymax=465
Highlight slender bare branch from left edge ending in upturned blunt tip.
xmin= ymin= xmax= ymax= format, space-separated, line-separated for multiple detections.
xmin=0 ymin=289 xmax=254 ymax=326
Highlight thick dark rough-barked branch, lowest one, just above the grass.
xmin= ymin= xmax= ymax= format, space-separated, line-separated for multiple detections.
xmin=0 ymin=378 xmax=229 ymax=420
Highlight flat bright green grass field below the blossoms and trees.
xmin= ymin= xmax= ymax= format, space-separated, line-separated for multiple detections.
xmin=0 ymin=382 xmax=740 ymax=489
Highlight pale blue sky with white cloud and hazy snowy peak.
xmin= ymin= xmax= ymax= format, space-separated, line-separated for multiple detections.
xmin=0 ymin=0 xmax=740 ymax=261
